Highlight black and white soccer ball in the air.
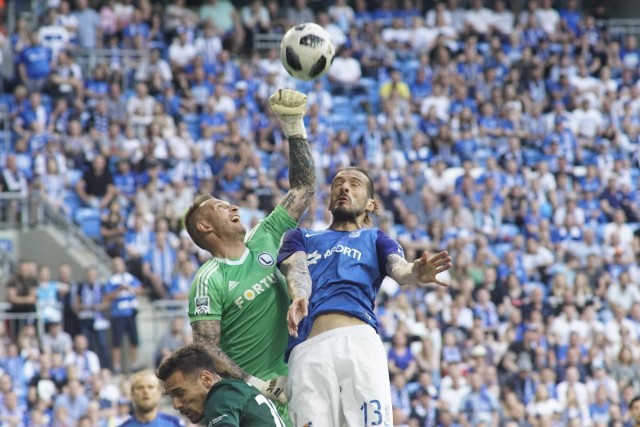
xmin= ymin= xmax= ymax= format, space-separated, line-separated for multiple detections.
xmin=280 ymin=22 xmax=336 ymax=80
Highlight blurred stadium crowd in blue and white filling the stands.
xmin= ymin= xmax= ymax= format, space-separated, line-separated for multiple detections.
xmin=0 ymin=0 xmax=640 ymax=427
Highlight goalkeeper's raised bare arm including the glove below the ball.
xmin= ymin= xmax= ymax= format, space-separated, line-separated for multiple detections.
xmin=269 ymin=89 xmax=316 ymax=221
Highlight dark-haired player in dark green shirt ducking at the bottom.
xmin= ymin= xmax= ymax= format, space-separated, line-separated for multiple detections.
xmin=156 ymin=343 xmax=285 ymax=427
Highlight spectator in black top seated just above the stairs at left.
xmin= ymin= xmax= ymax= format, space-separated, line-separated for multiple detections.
xmin=76 ymin=155 xmax=116 ymax=209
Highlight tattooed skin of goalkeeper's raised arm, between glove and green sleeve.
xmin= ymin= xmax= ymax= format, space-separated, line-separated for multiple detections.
xmin=280 ymin=138 xmax=316 ymax=221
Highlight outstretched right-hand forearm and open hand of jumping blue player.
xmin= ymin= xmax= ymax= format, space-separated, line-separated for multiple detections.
xmin=386 ymin=251 xmax=452 ymax=286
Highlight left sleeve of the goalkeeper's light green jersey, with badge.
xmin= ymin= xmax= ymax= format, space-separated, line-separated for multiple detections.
xmin=189 ymin=258 xmax=226 ymax=323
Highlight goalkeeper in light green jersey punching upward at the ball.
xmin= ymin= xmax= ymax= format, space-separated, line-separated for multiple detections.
xmin=184 ymin=89 xmax=316 ymax=424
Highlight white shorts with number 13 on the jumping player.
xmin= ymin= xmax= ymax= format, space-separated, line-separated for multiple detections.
xmin=287 ymin=325 xmax=393 ymax=427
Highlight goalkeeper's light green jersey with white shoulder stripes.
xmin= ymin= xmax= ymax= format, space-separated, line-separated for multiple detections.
xmin=189 ymin=206 xmax=297 ymax=380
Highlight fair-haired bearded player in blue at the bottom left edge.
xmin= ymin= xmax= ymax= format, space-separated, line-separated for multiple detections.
xmin=120 ymin=371 xmax=184 ymax=427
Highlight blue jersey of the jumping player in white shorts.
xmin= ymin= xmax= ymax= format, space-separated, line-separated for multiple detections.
xmin=278 ymin=228 xmax=404 ymax=358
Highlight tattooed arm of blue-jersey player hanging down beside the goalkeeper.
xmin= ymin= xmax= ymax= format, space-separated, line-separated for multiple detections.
xmin=280 ymin=251 xmax=311 ymax=337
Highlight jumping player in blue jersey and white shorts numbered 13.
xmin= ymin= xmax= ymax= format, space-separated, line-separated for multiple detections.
xmin=278 ymin=168 xmax=451 ymax=427
